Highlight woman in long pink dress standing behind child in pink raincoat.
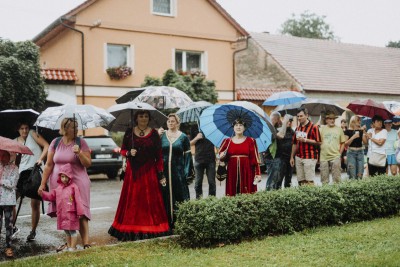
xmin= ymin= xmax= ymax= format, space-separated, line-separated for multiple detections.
xmin=38 ymin=118 xmax=92 ymax=249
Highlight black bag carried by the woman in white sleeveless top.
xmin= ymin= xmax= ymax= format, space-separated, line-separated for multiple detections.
xmin=17 ymin=164 xmax=43 ymax=200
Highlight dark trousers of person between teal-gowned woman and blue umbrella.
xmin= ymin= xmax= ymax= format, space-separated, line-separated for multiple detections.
xmin=194 ymin=161 xmax=216 ymax=199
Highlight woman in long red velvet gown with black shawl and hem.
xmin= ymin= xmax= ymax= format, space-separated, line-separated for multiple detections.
xmin=108 ymin=110 xmax=171 ymax=241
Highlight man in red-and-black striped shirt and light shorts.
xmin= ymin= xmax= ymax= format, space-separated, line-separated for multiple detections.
xmin=290 ymin=108 xmax=321 ymax=186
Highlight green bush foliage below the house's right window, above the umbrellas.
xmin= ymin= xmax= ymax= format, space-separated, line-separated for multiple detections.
xmin=142 ymin=69 xmax=218 ymax=103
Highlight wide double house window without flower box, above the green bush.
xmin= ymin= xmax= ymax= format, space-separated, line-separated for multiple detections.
xmin=175 ymin=50 xmax=205 ymax=72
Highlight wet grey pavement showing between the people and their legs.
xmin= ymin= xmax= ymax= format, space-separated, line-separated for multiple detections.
xmin=0 ymin=174 xmax=344 ymax=262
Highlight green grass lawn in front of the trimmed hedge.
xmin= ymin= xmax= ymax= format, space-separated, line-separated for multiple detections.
xmin=7 ymin=216 xmax=400 ymax=267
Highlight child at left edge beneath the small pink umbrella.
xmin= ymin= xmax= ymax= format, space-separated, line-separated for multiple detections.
xmin=0 ymin=149 xmax=19 ymax=258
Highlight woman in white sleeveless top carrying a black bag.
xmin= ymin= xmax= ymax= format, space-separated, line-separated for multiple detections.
xmin=13 ymin=121 xmax=49 ymax=242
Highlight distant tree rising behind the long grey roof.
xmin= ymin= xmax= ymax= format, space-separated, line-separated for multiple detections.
xmin=280 ymin=10 xmax=336 ymax=40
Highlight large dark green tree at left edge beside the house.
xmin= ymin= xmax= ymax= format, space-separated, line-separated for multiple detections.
xmin=0 ymin=39 xmax=47 ymax=111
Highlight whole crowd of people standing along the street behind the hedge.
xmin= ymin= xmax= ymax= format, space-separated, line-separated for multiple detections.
xmin=0 ymin=108 xmax=400 ymax=257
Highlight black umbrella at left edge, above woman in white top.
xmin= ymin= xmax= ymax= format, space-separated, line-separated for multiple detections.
xmin=0 ymin=109 xmax=39 ymax=139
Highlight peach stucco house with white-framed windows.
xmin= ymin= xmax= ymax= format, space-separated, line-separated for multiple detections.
xmin=33 ymin=0 xmax=249 ymax=116
